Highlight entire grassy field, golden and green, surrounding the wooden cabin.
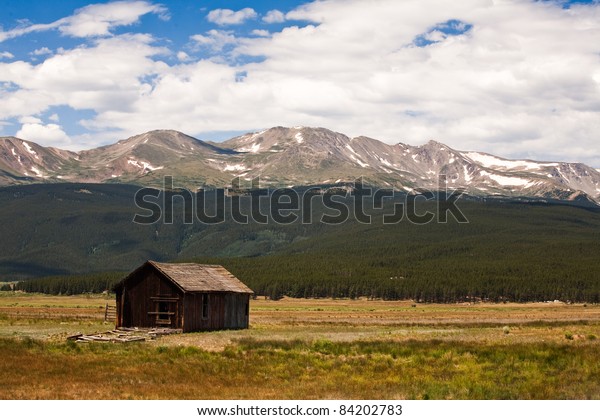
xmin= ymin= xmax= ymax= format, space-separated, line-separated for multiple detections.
xmin=0 ymin=293 xmax=600 ymax=399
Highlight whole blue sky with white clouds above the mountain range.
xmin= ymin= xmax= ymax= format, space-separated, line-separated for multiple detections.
xmin=0 ymin=0 xmax=600 ymax=168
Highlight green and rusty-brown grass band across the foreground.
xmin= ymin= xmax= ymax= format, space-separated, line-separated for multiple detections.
xmin=0 ymin=339 xmax=600 ymax=399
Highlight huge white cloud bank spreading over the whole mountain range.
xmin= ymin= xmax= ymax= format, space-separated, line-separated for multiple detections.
xmin=0 ymin=0 xmax=600 ymax=167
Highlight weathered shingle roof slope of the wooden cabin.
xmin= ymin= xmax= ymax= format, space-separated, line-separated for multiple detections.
xmin=148 ymin=261 xmax=254 ymax=294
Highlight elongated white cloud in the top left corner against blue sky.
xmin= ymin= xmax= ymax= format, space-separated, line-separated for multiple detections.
xmin=0 ymin=0 xmax=168 ymax=42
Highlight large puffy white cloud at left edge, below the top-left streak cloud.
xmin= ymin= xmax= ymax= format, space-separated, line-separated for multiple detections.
xmin=0 ymin=35 xmax=168 ymax=119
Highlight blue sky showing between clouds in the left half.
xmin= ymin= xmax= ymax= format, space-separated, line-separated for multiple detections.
xmin=0 ymin=0 xmax=310 ymax=143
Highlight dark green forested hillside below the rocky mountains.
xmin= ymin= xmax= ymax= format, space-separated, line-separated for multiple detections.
xmin=0 ymin=184 xmax=600 ymax=302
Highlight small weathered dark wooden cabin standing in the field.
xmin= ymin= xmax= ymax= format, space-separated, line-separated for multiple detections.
xmin=115 ymin=261 xmax=254 ymax=332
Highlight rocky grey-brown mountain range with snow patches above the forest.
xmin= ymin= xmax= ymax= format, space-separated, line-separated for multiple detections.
xmin=0 ymin=127 xmax=600 ymax=204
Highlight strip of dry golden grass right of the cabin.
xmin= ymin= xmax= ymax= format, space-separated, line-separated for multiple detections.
xmin=161 ymin=298 xmax=600 ymax=351
